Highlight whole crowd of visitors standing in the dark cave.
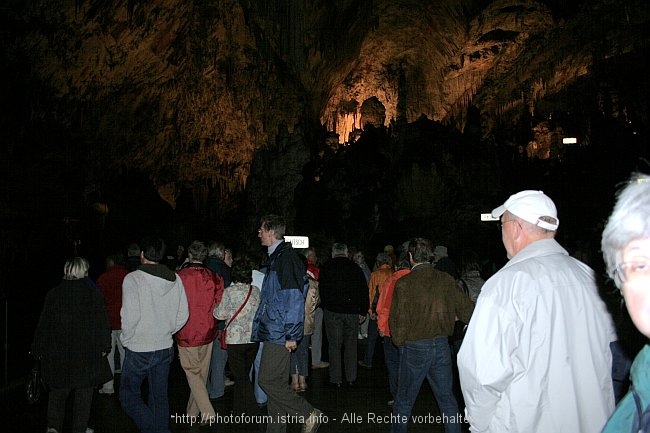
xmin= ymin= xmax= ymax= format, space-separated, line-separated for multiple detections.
xmin=32 ymin=174 xmax=650 ymax=433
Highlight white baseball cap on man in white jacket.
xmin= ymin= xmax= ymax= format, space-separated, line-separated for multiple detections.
xmin=492 ymin=190 xmax=560 ymax=230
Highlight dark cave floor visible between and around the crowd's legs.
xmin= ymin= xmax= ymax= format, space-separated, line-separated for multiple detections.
xmin=0 ymin=342 xmax=460 ymax=433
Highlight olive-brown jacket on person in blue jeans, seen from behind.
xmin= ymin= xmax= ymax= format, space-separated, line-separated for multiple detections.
xmin=388 ymin=263 xmax=474 ymax=346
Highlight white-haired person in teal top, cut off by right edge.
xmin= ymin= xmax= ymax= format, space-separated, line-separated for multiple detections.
xmin=602 ymin=174 xmax=650 ymax=433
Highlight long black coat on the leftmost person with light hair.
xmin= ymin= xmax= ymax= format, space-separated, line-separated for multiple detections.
xmin=32 ymin=280 xmax=113 ymax=388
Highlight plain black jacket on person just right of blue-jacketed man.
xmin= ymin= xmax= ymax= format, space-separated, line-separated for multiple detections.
xmin=318 ymin=257 xmax=368 ymax=316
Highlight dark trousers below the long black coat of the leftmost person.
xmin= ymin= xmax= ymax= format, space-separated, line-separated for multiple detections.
xmin=47 ymin=386 xmax=93 ymax=433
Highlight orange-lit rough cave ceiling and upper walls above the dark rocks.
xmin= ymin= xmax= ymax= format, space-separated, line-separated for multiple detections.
xmin=1 ymin=0 xmax=650 ymax=215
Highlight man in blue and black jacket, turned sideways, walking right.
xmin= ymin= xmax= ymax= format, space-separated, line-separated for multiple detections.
xmin=251 ymin=215 xmax=322 ymax=433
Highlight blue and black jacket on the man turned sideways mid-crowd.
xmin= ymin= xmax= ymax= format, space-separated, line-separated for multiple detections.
xmin=251 ymin=241 xmax=308 ymax=344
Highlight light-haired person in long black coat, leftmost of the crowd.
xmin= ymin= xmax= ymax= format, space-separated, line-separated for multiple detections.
xmin=32 ymin=257 xmax=113 ymax=433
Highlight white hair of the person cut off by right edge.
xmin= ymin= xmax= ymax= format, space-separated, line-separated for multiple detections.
xmin=601 ymin=173 xmax=650 ymax=288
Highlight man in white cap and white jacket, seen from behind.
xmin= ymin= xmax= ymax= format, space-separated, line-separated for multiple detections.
xmin=458 ymin=191 xmax=616 ymax=433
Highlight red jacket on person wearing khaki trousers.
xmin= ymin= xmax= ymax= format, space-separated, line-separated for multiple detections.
xmin=174 ymin=263 xmax=224 ymax=347
